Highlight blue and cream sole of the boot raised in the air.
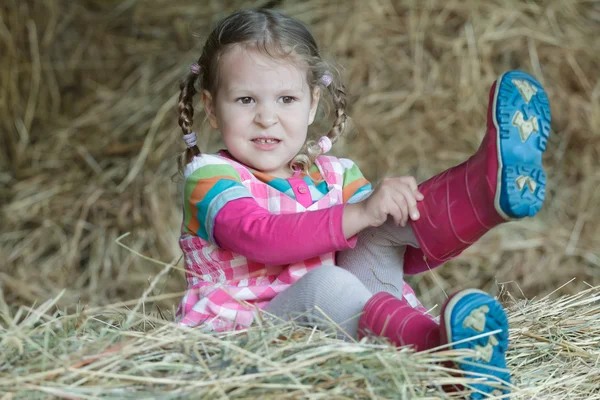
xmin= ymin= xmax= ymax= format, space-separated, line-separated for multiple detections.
xmin=492 ymin=71 xmax=551 ymax=219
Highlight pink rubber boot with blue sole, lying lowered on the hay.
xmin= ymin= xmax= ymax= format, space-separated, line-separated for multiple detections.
xmin=359 ymin=289 xmax=510 ymax=399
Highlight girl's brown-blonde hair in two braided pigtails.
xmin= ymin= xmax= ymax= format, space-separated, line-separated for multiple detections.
xmin=178 ymin=9 xmax=348 ymax=174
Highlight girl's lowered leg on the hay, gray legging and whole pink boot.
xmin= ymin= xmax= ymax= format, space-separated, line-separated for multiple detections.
xmin=265 ymin=266 xmax=510 ymax=398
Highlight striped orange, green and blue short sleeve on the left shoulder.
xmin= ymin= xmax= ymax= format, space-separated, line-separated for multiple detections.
xmin=183 ymin=155 xmax=253 ymax=243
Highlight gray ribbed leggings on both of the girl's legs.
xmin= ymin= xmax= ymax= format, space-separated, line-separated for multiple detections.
xmin=265 ymin=219 xmax=418 ymax=338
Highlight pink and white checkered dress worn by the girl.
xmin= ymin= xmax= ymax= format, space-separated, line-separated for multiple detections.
xmin=177 ymin=156 xmax=425 ymax=332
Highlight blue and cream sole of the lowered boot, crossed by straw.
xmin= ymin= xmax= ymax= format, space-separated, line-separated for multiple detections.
xmin=443 ymin=289 xmax=510 ymax=399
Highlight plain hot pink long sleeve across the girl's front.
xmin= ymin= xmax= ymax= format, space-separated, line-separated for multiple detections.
xmin=214 ymin=199 xmax=356 ymax=265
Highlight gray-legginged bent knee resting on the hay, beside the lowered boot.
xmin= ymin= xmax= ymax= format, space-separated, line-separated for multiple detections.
xmin=265 ymin=265 xmax=371 ymax=338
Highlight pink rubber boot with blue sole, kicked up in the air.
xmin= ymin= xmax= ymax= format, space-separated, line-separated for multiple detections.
xmin=404 ymin=71 xmax=550 ymax=274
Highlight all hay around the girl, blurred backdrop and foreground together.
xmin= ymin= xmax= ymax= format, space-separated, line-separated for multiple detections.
xmin=0 ymin=0 xmax=600 ymax=399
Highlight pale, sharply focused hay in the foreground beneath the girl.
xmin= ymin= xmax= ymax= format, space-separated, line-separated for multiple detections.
xmin=0 ymin=280 xmax=600 ymax=399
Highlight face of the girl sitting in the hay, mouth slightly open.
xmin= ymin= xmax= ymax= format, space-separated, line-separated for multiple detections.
xmin=202 ymin=46 xmax=320 ymax=178
